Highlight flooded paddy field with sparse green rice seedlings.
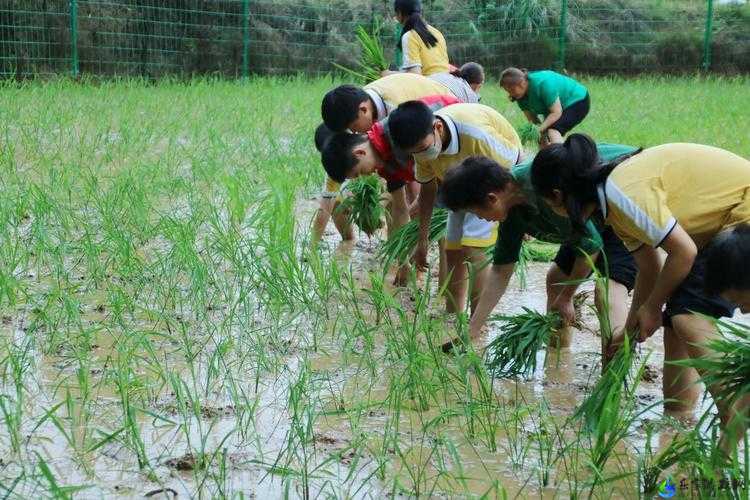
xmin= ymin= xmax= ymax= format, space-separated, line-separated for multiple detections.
xmin=0 ymin=77 xmax=750 ymax=498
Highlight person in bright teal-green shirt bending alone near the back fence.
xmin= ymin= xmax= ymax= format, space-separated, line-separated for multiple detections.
xmin=500 ymin=68 xmax=591 ymax=146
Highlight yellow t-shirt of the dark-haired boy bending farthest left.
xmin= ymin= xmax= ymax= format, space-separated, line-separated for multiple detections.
xmin=363 ymin=73 xmax=452 ymax=120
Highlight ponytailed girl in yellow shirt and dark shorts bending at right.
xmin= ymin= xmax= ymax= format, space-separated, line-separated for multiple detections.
xmin=532 ymin=134 xmax=750 ymax=449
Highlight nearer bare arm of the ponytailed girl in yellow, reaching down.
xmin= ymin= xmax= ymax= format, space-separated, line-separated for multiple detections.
xmin=625 ymin=224 xmax=698 ymax=342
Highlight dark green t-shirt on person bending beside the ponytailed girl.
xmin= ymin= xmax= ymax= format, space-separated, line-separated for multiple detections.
xmin=493 ymin=144 xmax=636 ymax=265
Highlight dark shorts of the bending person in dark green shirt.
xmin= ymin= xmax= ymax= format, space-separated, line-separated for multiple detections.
xmin=554 ymin=227 xmax=638 ymax=291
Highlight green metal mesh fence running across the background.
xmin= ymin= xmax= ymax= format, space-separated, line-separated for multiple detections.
xmin=0 ymin=0 xmax=750 ymax=78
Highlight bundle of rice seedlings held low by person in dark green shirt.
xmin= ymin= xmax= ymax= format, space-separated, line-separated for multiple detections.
xmin=486 ymin=308 xmax=562 ymax=378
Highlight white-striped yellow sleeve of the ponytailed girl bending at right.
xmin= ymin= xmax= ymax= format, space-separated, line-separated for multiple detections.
xmin=605 ymin=178 xmax=677 ymax=252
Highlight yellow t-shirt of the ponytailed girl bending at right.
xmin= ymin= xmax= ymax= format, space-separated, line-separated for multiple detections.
xmin=599 ymin=143 xmax=750 ymax=252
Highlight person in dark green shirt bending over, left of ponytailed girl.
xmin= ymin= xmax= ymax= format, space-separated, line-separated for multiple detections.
xmin=440 ymin=144 xmax=637 ymax=355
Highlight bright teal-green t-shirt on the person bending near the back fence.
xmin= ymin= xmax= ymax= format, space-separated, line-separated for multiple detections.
xmin=518 ymin=71 xmax=588 ymax=117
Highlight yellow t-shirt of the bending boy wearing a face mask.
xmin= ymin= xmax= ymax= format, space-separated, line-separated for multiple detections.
xmin=415 ymin=104 xmax=521 ymax=183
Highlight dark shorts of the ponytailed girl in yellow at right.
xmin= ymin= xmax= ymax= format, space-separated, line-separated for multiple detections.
xmin=662 ymin=252 xmax=737 ymax=326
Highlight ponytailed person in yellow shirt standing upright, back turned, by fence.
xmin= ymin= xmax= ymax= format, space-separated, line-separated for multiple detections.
xmin=384 ymin=0 xmax=450 ymax=76
